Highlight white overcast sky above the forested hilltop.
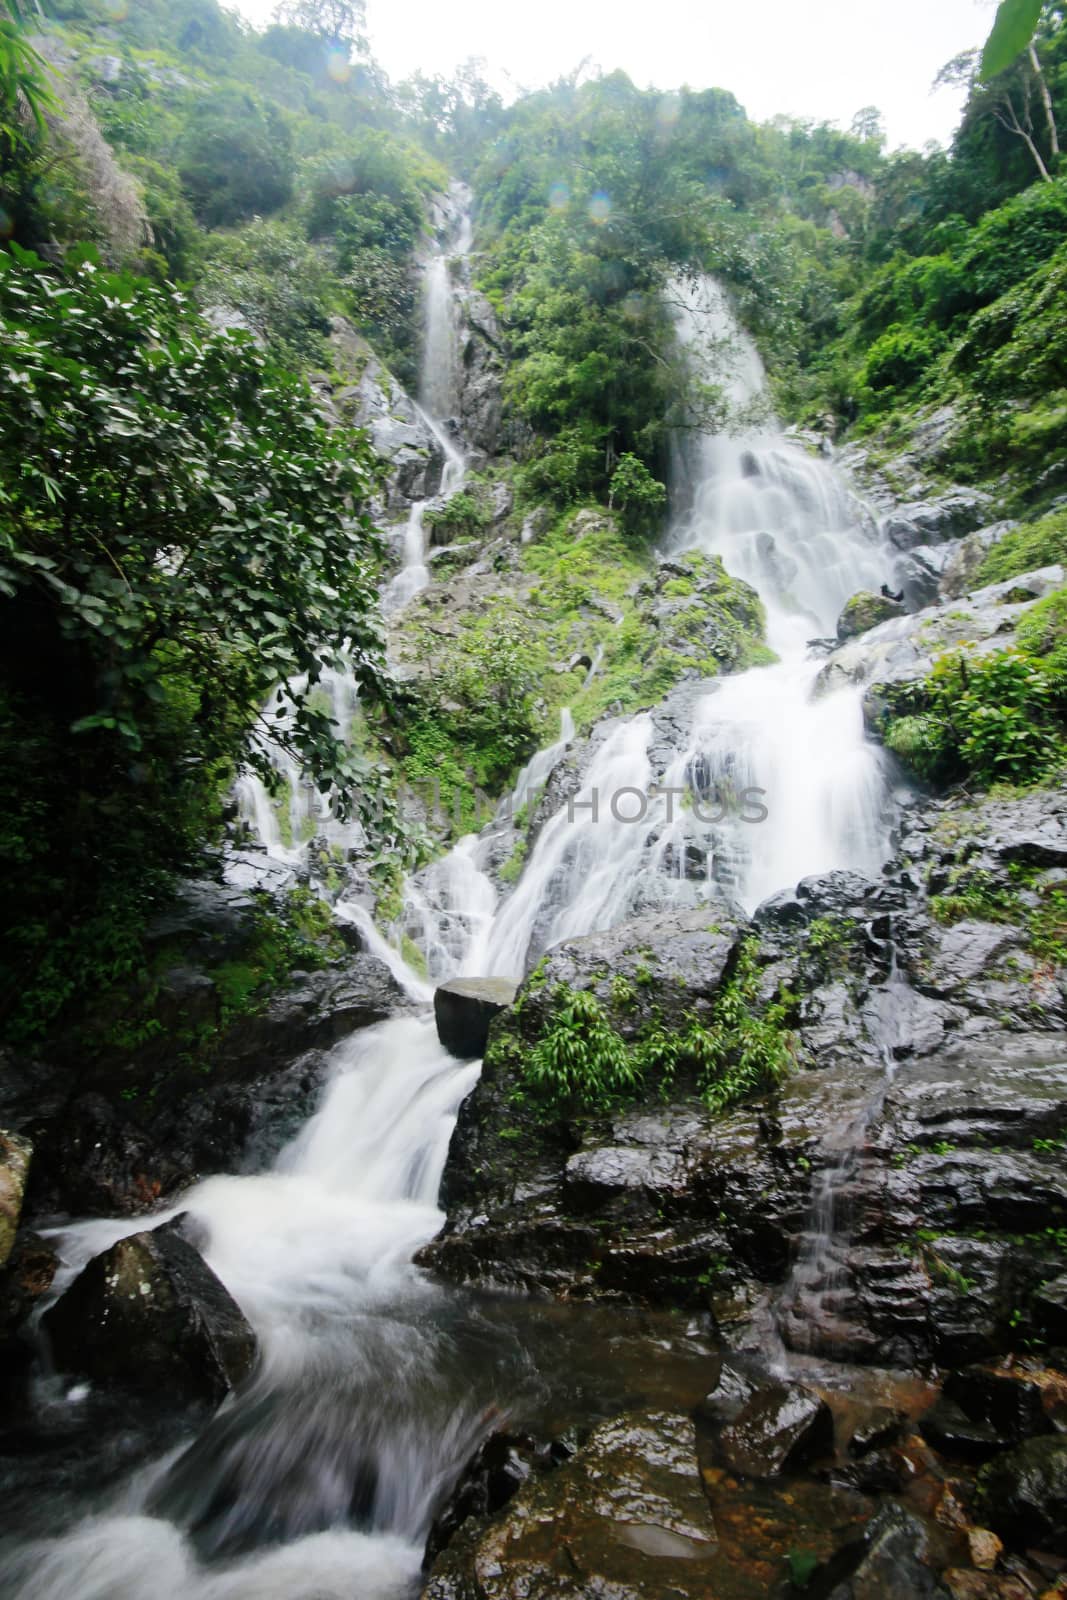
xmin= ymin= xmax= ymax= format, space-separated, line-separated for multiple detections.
xmin=237 ymin=0 xmax=995 ymax=147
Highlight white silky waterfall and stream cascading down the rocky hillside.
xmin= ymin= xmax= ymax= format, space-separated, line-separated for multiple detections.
xmin=10 ymin=249 xmax=908 ymax=1600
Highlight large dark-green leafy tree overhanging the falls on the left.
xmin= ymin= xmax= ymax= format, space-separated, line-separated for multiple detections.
xmin=0 ymin=246 xmax=388 ymax=1032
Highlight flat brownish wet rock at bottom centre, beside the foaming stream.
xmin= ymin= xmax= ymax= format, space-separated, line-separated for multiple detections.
xmin=424 ymin=1411 xmax=718 ymax=1600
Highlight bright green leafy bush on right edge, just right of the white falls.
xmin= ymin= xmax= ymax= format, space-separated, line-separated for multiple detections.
xmin=885 ymin=650 xmax=1061 ymax=784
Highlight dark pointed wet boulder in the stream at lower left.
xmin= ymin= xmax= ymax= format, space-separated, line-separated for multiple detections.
xmin=42 ymin=1219 xmax=256 ymax=1405
